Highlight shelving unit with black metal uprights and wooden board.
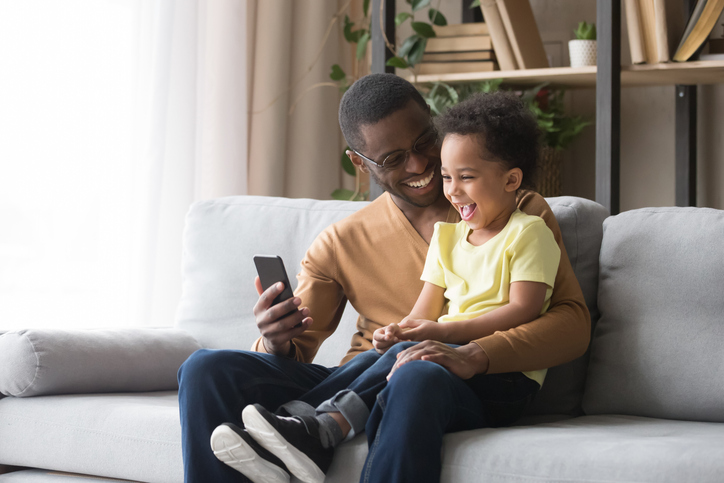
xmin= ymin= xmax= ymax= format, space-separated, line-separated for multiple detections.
xmin=371 ymin=0 xmax=708 ymax=214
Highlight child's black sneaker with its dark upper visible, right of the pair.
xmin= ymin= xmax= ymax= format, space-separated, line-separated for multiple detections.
xmin=241 ymin=404 xmax=334 ymax=483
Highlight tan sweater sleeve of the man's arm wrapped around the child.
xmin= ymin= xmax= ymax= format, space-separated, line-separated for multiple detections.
xmin=473 ymin=192 xmax=591 ymax=374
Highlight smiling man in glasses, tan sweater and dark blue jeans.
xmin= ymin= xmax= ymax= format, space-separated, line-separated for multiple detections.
xmin=179 ymin=74 xmax=590 ymax=482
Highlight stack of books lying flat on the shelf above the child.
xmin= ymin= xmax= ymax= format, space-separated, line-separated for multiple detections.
xmin=415 ymin=23 xmax=498 ymax=75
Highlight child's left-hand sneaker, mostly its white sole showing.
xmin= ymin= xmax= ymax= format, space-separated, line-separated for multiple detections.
xmin=211 ymin=423 xmax=290 ymax=483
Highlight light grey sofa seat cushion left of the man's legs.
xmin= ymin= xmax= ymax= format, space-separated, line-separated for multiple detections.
xmin=0 ymin=391 xmax=183 ymax=483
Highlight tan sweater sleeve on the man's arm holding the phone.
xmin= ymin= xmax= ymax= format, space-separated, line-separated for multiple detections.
xmin=252 ymin=226 xmax=347 ymax=362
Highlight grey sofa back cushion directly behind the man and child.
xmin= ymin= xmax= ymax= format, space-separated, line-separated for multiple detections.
xmin=176 ymin=196 xmax=607 ymax=386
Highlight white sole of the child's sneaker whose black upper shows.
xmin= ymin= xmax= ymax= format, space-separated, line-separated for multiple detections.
xmin=241 ymin=405 xmax=324 ymax=483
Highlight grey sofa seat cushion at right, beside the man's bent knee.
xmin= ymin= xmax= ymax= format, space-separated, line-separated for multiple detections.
xmin=325 ymin=416 xmax=724 ymax=483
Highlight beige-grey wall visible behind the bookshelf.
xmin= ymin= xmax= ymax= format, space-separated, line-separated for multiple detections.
xmin=422 ymin=0 xmax=724 ymax=210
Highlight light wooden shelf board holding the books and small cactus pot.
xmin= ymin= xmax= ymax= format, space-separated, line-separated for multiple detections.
xmin=407 ymin=60 xmax=724 ymax=89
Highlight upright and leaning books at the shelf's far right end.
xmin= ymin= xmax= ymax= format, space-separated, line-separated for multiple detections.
xmin=624 ymin=0 xmax=724 ymax=64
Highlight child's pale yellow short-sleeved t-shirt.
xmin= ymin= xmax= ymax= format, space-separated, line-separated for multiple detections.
xmin=420 ymin=210 xmax=561 ymax=386
